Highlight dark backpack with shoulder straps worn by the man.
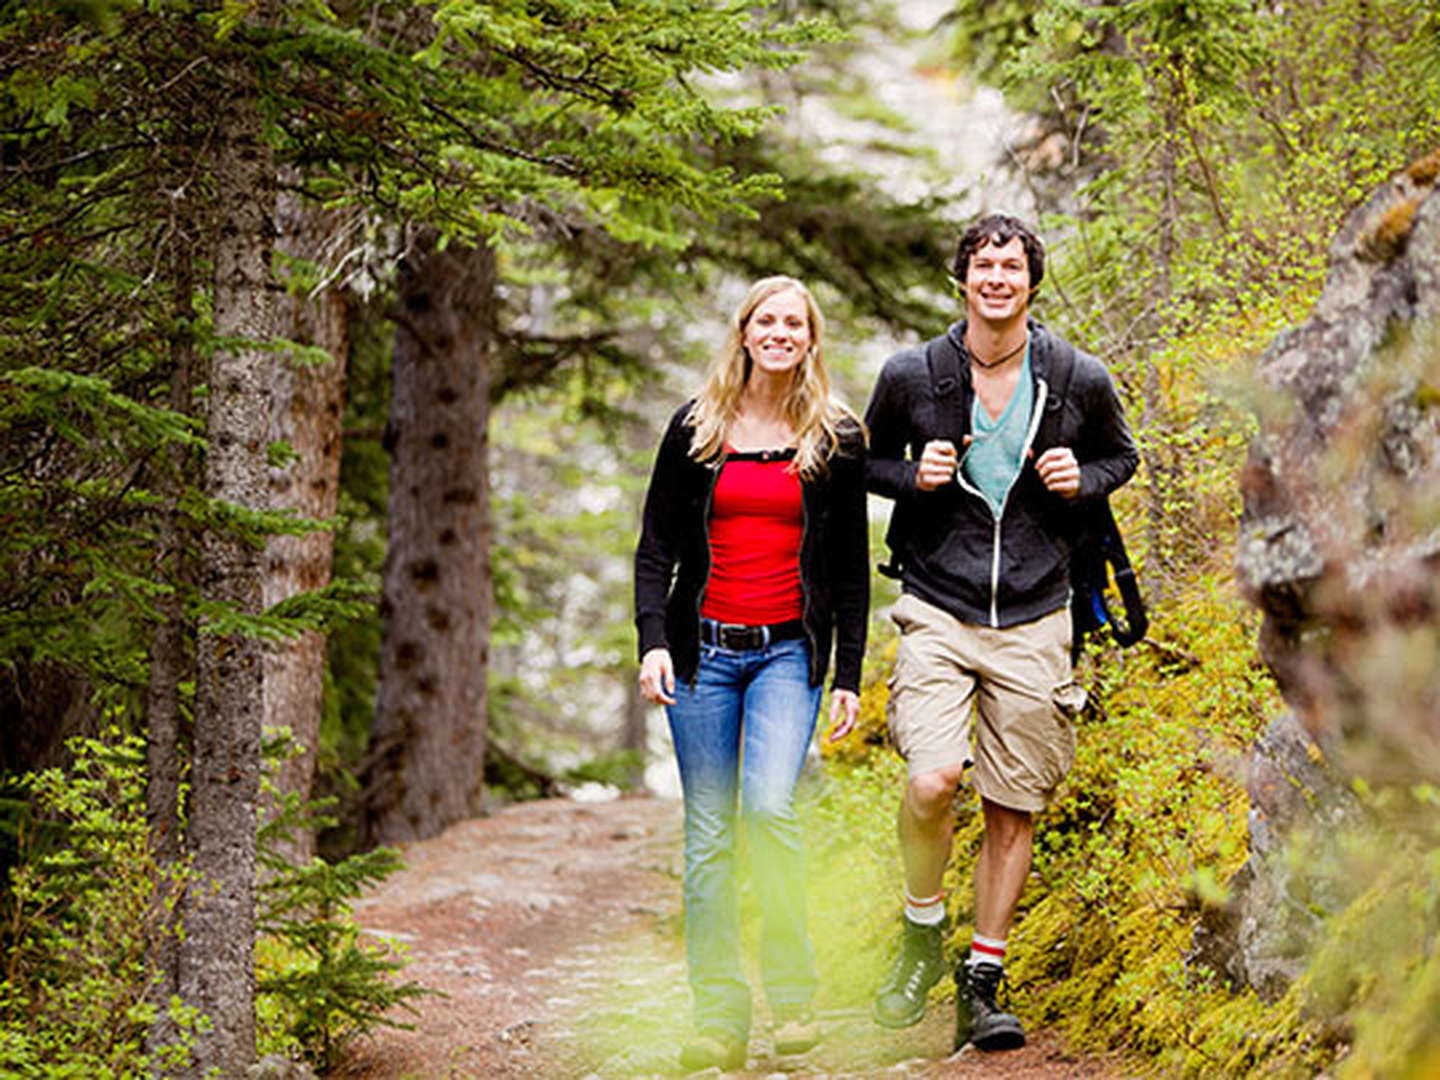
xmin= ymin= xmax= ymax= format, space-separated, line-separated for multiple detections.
xmin=880 ymin=334 xmax=1149 ymax=660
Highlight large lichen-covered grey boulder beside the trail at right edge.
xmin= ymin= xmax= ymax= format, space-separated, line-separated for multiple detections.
xmin=1221 ymin=150 xmax=1440 ymax=996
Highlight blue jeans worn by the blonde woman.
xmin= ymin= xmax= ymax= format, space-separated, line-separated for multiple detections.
xmin=667 ymin=639 xmax=821 ymax=1040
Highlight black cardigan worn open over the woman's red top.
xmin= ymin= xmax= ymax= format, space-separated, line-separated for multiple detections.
xmin=635 ymin=402 xmax=870 ymax=693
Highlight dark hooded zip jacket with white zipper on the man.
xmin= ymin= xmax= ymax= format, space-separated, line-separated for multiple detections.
xmin=865 ymin=320 xmax=1139 ymax=626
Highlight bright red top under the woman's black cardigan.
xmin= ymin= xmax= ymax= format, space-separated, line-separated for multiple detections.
xmin=700 ymin=452 xmax=805 ymax=626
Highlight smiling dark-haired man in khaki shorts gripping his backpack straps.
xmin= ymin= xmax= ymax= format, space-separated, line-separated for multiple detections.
xmin=865 ymin=215 xmax=1139 ymax=1050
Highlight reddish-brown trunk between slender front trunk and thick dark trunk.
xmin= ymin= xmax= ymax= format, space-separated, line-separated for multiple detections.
xmin=264 ymin=185 xmax=348 ymax=861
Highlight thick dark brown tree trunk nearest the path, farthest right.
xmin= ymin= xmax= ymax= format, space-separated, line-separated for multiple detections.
xmin=364 ymin=238 xmax=495 ymax=844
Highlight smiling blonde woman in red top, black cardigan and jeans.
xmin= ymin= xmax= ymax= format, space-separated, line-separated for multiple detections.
xmin=635 ymin=276 xmax=870 ymax=1070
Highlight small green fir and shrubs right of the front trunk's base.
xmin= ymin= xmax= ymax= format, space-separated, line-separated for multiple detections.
xmin=256 ymin=736 xmax=436 ymax=1070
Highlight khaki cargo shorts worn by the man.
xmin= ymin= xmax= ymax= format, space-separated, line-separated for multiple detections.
xmin=888 ymin=593 xmax=1086 ymax=811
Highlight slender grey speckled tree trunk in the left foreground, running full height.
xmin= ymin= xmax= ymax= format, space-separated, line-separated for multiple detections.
xmin=180 ymin=29 xmax=275 ymax=1077
